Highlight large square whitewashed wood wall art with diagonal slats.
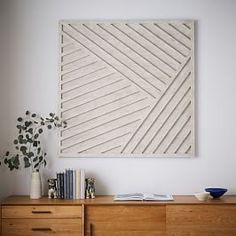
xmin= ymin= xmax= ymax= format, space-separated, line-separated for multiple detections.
xmin=60 ymin=20 xmax=195 ymax=157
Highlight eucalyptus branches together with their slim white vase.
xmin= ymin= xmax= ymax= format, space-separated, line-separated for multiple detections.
xmin=0 ymin=111 xmax=66 ymax=199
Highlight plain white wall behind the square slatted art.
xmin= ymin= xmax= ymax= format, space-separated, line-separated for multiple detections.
xmin=0 ymin=0 xmax=236 ymax=197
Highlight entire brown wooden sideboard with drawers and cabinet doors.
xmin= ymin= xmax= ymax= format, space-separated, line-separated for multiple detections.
xmin=1 ymin=196 xmax=236 ymax=236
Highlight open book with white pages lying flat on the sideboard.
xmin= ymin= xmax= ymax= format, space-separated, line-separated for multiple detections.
xmin=114 ymin=193 xmax=174 ymax=201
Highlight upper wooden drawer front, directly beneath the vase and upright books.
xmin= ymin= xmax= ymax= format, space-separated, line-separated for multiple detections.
xmin=2 ymin=206 xmax=82 ymax=219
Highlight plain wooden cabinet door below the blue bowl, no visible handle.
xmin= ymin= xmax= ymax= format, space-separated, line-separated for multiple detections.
xmin=166 ymin=205 xmax=236 ymax=236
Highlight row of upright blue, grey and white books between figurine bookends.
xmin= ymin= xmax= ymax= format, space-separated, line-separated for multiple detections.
xmin=57 ymin=169 xmax=85 ymax=199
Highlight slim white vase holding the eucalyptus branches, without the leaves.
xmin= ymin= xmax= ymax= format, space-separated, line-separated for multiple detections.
xmin=30 ymin=171 xmax=42 ymax=199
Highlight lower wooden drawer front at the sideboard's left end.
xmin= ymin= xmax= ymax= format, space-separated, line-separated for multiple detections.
xmin=2 ymin=219 xmax=81 ymax=236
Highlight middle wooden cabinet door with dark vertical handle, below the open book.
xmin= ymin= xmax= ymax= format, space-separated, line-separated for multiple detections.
xmin=85 ymin=205 xmax=166 ymax=236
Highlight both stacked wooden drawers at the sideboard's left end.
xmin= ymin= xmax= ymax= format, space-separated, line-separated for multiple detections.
xmin=2 ymin=204 xmax=82 ymax=236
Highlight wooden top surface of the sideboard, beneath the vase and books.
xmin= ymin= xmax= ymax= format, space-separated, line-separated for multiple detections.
xmin=1 ymin=195 xmax=236 ymax=206
